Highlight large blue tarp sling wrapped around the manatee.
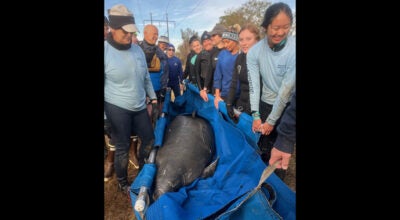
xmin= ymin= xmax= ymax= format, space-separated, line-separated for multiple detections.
xmin=131 ymin=84 xmax=296 ymax=220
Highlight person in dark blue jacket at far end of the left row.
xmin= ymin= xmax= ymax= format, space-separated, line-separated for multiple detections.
xmin=167 ymin=43 xmax=183 ymax=97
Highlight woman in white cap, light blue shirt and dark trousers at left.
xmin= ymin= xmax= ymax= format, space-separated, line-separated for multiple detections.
xmin=104 ymin=4 xmax=158 ymax=197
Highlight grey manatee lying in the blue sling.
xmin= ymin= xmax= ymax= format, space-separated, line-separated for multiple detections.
xmin=153 ymin=115 xmax=217 ymax=200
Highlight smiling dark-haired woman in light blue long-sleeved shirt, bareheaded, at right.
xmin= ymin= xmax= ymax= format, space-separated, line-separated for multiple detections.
xmin=247 ymin=2 xmax=296 ymax=179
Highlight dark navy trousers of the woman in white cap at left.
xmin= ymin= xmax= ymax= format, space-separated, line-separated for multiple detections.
xmin=104 ymin=102 xmax=154 ymax=186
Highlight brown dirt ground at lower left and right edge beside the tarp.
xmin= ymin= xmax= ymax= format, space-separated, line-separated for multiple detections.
xmin=104 ymin=142 xmax=296 ymax=220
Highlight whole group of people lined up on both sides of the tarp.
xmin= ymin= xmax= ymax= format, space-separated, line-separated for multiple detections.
xmin=104 ymin=3 xmax=296 ymax=198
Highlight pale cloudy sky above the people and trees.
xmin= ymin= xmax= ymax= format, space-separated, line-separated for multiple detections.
xmin=104 ymin=0 xmax=296 ymax=47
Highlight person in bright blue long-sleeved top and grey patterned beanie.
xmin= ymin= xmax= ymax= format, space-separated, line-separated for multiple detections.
xmin=213 ymin=24 xmax=240 ymax=109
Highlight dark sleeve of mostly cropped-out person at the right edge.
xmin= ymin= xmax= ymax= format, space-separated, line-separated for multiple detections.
xmin=274 ymin=91 xmax=296 ymax=154
